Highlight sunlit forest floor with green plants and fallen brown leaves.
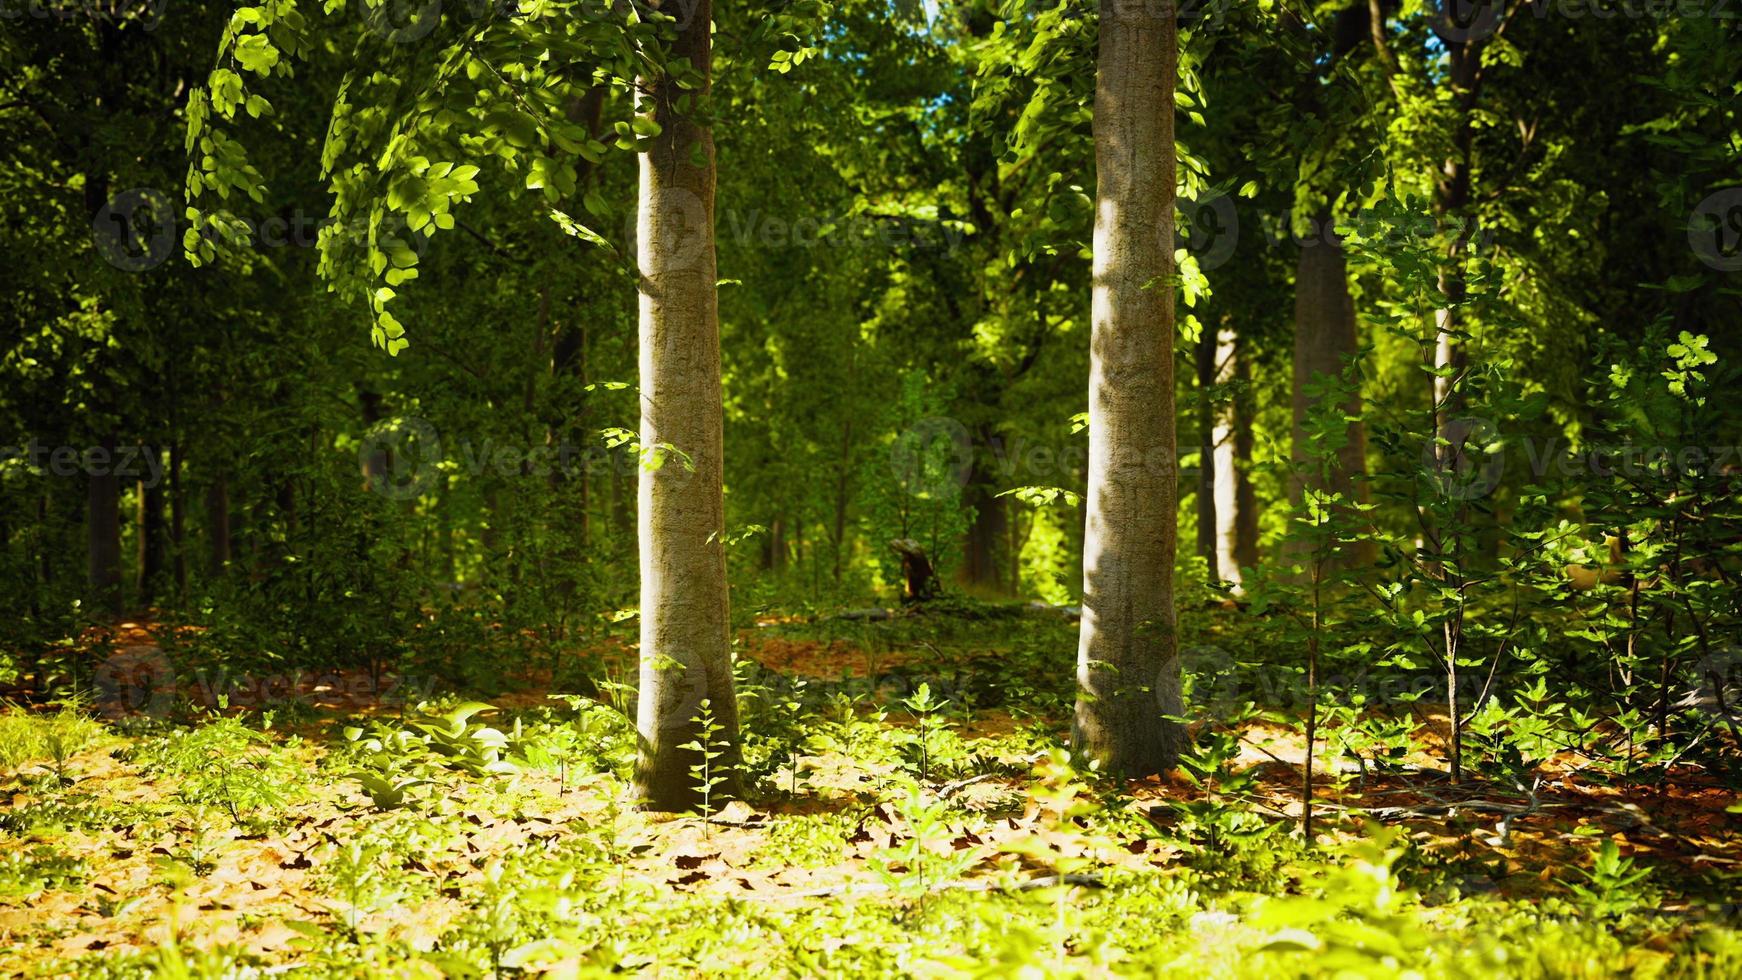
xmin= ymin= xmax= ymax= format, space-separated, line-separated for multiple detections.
xmin=0 ymin=609 xmax=1742 ymax=977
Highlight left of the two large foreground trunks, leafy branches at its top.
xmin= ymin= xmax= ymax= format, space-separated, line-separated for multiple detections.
xmin=636 ymin=0 xmax=739 ymax=811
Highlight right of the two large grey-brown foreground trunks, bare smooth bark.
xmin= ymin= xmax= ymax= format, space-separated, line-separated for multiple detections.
xmin=1073 ymin=2 xmax=1185 ymax=775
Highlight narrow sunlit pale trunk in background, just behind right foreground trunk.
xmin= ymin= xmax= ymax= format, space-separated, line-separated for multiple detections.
xmin=1211 ymin=327 xmax=1258 ymax=587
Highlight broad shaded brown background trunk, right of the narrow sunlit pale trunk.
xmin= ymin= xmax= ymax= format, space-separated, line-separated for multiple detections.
xmin=1291 ymin=212 xmax=1373 ymax=564
